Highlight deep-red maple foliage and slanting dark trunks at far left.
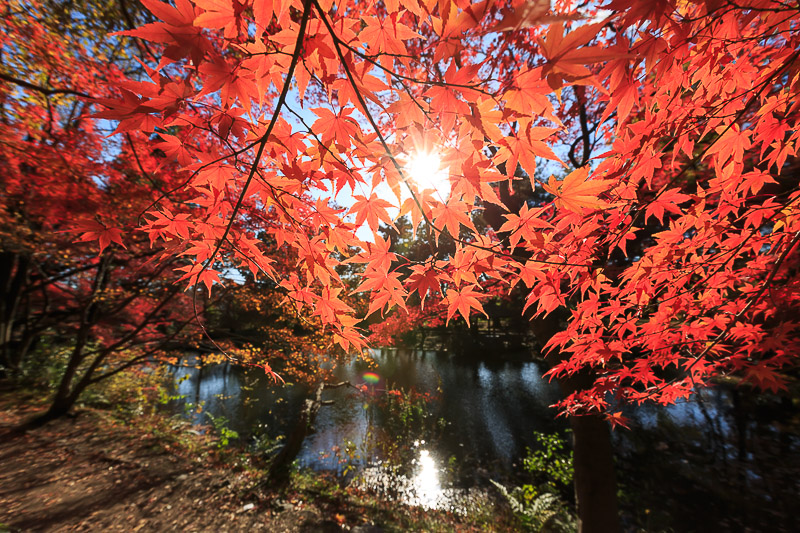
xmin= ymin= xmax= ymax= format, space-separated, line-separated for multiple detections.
xmin=0 ymin=3 xmax=209 ymax=421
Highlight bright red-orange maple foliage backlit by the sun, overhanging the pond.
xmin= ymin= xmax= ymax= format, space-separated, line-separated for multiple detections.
xmin=9 ymin=0 xmax=800 ymax=527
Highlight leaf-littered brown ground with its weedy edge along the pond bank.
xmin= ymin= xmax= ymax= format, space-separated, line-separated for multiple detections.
xmin=0 ymin=395 xmax=506 ymax=533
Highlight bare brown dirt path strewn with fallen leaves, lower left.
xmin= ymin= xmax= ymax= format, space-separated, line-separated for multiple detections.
xmin=0 ymin=409 xmax=354 ymax=532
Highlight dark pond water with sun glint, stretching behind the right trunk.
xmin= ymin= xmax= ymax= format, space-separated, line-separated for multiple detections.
xmin=159 ymin=350 xmax=800 ymax=531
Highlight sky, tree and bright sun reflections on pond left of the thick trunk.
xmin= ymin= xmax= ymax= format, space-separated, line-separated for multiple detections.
xmin=165 ymin=350 xmax=563 ymax=510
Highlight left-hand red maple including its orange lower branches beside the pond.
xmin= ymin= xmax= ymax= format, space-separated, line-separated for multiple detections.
xmin=0 ymin=2 xmax=338 ymax=423
